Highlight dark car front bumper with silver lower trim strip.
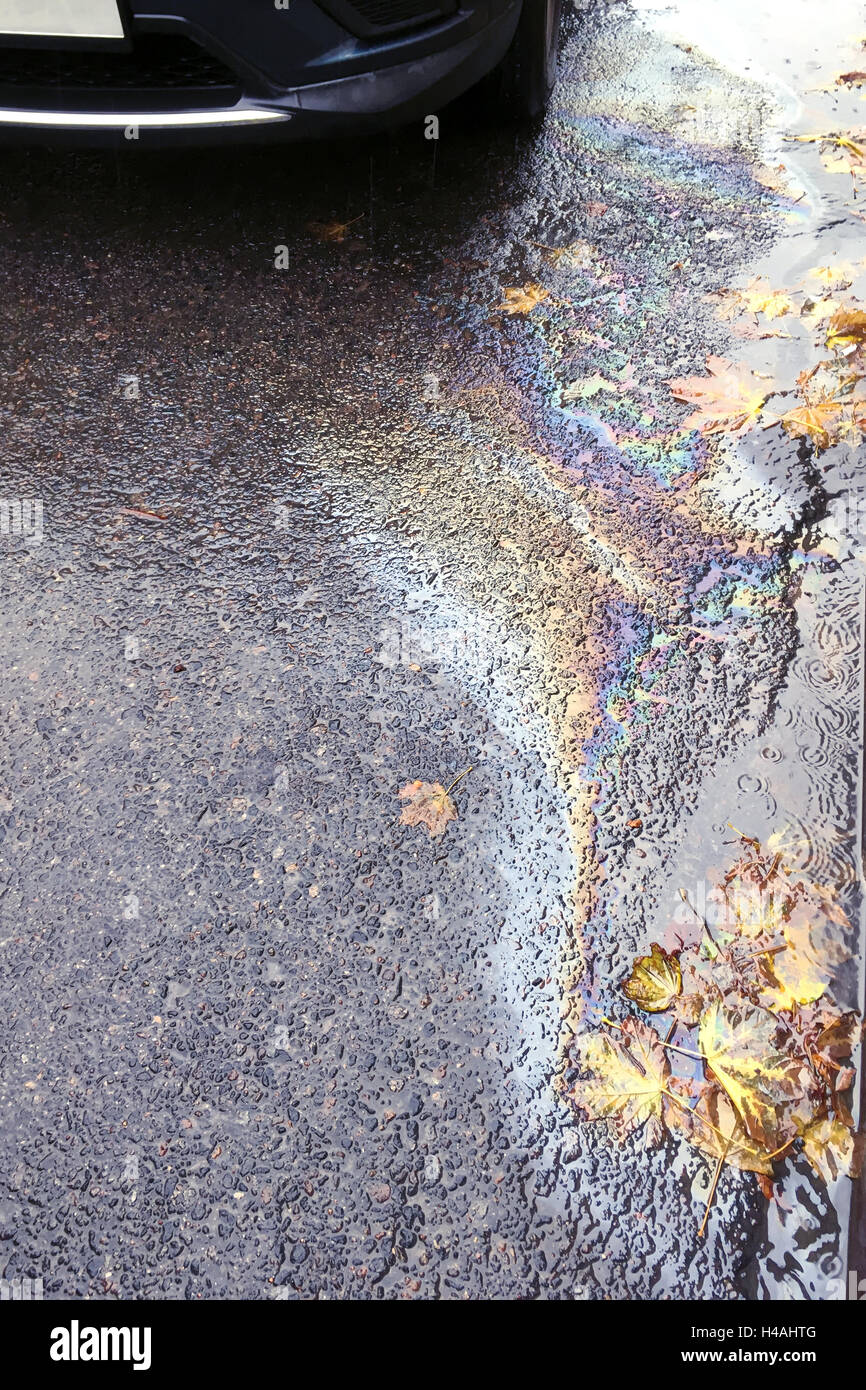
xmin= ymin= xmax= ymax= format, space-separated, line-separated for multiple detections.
xmin=0 ymin=0 xmax=530 ymax=145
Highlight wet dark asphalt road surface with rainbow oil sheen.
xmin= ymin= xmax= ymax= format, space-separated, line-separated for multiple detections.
xmin=0 ymin=4 xmax=856 ymax=1300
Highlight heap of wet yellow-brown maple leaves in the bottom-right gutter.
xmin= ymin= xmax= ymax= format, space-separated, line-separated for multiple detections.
xmin=574 ymin=835 xmax=862 ymax=1219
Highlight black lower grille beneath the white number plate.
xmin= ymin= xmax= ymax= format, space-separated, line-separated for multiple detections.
xmin=0 ymin=33 xmax=239 ymax=106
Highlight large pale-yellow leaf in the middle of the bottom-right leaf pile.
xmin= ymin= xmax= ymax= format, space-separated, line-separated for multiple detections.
xmin=698 ymin=1004 xmax=802 ymax=1151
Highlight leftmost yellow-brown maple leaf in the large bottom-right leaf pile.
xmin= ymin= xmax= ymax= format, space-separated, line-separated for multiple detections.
xmin=574 ymin=1017 xmax=670 ymax=1138
